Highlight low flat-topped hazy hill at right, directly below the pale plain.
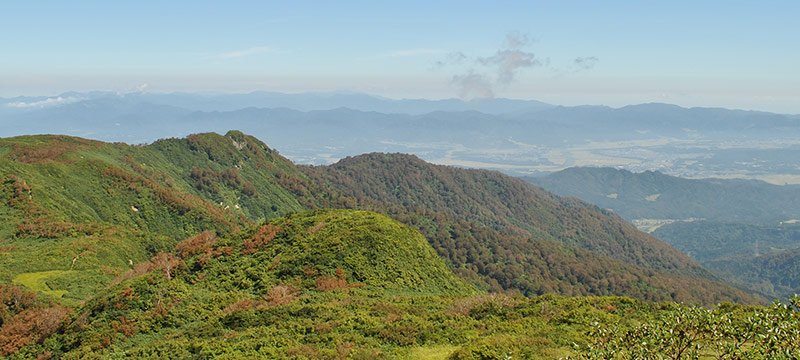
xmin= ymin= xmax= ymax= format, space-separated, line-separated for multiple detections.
xmin=525 ymin=167 xmax=800 ymax=223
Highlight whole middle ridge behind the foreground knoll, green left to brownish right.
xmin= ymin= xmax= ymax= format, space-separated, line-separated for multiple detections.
xmin=0 ymin=131 xmax=756 ymax=303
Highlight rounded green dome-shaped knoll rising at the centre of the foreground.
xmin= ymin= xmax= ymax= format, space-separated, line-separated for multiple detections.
xmin=202 ymin=210 xmax=471 ymax=294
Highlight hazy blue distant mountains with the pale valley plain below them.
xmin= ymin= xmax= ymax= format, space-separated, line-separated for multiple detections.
xmin=0 ymin=92 xmax=800 ymax=183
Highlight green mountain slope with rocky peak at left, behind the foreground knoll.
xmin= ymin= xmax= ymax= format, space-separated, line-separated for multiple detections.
xmin=0 ymin=132 xmax=305 ymax=301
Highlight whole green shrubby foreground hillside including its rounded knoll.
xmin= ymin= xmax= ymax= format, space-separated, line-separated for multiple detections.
xmin=6 ymin=210 xmax=797 ymax=359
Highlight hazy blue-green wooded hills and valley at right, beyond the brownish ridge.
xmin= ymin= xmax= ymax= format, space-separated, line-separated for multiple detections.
xmin=527 ymin=168 xmax=800 ymax=298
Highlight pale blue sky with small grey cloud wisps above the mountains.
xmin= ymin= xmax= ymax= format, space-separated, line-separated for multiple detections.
xmin=0 ymin=0 xmax=800 ymax=114
